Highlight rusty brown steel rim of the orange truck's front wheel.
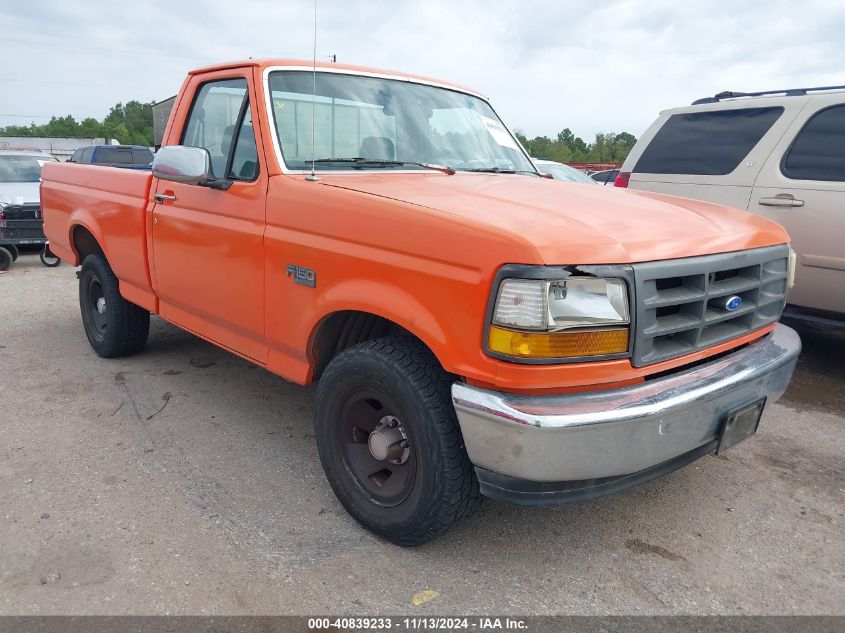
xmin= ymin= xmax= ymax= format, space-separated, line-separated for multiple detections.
xmin=339 ymin=390 xmax=417 ymax=507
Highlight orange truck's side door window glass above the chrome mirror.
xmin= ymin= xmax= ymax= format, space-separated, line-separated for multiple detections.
xmin=182 ymin=79 xmax=247 ymax=178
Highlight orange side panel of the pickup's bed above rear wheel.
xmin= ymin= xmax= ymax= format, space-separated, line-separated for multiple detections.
xmin=41 ymin=163 xmax=157 ymax=312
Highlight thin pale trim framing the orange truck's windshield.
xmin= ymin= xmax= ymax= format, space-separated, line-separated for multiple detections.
xmin=262 ymin=64 xmax=539 ymax=175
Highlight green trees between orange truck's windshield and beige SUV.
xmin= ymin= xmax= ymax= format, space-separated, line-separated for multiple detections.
xmin=514 ymin=128 xmax=637 ymax=163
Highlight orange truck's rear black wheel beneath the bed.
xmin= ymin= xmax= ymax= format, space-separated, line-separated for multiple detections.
xmin=79 ymin=253 xmax=150 ymax=358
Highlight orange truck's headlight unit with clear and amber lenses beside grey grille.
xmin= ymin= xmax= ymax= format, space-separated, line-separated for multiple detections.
xmin=487 ymin=275 xmax=630 ymax=359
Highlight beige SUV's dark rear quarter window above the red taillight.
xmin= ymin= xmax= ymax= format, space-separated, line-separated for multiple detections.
xmin=634 ymin=107 xmax=783 ymax=176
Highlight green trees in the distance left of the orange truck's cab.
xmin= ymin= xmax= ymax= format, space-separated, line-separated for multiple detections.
xmin=0 ymin=101 xmax=153 ymax=145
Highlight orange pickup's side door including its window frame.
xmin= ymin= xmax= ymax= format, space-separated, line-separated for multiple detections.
xmin=152 ymin=71 xmax=269 ymax=363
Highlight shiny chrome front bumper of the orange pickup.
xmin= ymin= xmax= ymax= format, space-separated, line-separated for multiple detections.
xmin=452 ymin=324 xmax=801 ymax=505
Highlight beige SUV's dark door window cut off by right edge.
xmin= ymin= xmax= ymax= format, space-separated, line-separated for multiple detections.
xmin=783 ymin=105 xmax=845 ymax=182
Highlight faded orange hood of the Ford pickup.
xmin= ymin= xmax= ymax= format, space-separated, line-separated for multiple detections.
xmin=321 ymin=172 xmax=789 ymax=264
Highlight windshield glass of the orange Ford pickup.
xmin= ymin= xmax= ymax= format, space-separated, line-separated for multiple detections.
xmin=269 ymin=71 xmax=535 ymax=173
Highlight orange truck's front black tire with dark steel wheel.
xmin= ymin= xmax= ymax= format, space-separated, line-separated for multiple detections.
xmin=315 ymin=336 xmax=480 ymax=546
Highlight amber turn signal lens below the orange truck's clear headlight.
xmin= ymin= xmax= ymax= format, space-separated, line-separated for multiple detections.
xmin=487 ymin=325 xmax=628 ymax=358
